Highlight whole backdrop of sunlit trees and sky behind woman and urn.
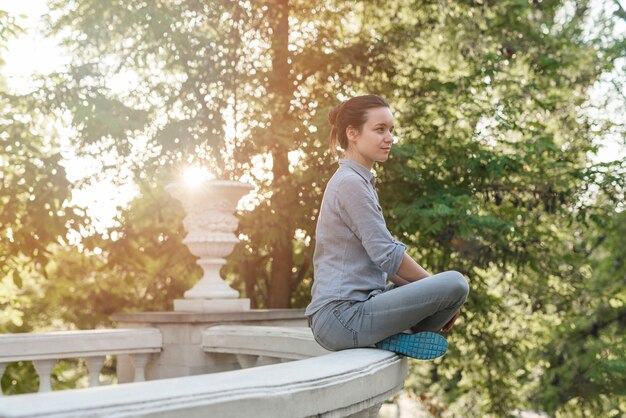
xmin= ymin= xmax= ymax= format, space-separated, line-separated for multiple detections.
xmin=0 ymin=0 xmax=626 ymax=417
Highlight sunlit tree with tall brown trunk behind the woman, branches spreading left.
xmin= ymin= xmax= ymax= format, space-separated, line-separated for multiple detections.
xmin=45 ymin=1 xmax=414 ymax=307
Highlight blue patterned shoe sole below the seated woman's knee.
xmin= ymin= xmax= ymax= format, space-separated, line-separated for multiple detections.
xmin=375 ymin=331 xmax=448 ymax=360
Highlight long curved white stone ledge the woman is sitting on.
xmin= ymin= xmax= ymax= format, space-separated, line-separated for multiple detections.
xmin=0 ymin=349 xmax=407 ymax=418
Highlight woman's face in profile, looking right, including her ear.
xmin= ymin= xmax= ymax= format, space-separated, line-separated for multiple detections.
xmin=346 ymin=107 xmax=393 ymax=168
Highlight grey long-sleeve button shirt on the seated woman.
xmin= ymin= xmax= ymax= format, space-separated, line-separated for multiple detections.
xmin=305 ymin=159 xmax=406 ymax=316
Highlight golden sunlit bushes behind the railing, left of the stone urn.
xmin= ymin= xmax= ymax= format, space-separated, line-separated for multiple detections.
xmin=21 ymin=174 xmax=201 ymax=329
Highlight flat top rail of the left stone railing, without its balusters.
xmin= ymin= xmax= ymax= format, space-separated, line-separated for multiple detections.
xmin=0 ymin=328 xmax=163 ymax=363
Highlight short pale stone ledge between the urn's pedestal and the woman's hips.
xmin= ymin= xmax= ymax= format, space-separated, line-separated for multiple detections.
xmin=202 ymin=325 xmax=330 ymax=360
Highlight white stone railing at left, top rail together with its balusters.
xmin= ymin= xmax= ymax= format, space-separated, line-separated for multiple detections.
xmin=0 ymin=328 xmax=162 ymax=396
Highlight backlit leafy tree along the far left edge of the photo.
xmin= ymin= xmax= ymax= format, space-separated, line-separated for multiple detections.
xmin=0 ymin=10 xmax=89 ymax=392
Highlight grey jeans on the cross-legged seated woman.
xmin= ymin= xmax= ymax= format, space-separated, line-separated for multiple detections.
xmin=311 ymin=271 xmax=469 ymax=351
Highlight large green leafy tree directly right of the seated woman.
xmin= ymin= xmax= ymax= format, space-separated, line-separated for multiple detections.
xmin=370 ymin=2 xmax=625 ymax=416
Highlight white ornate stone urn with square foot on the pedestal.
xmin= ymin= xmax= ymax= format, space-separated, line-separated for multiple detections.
xmin=165 ymin=180 xmax=253 ymax=312
